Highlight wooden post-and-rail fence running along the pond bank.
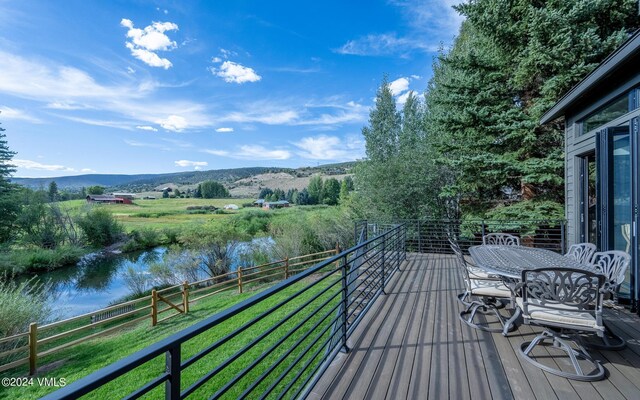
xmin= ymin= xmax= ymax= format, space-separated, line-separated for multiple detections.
xmin=0 ymin=248 xmax=340 ymax=375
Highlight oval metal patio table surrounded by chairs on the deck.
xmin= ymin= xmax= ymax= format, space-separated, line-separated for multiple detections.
xmin=469 ymin=245 xmax=594 ymax=336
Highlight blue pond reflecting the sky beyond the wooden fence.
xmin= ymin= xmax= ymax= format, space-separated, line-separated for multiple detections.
xmin=38 ymin=237 xmax=274 ymax=319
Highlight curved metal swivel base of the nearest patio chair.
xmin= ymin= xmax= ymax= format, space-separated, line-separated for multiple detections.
xmin=519 ymin=330 xmax=605 ymax=381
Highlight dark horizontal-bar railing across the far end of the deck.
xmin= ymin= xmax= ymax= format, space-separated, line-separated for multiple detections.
xmin=355 ymin=219 xmax=567 ymax=254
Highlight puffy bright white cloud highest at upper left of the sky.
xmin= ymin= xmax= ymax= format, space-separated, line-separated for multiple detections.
xmin=120 ymin=18 xmax=178 ymax=69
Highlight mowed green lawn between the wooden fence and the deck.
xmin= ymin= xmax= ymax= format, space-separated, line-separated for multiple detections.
xmin=0 ymin=276 xmax=340 ymax=399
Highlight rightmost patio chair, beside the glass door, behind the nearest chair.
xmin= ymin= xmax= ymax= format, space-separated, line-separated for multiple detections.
xmin=583 ymin=250 xmax=631 ymax=350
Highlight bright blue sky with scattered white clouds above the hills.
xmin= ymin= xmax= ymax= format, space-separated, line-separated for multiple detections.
xmin=0 ymin=0 xmax=461 ymax=177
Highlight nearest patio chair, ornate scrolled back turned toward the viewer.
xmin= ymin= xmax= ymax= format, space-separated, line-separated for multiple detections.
xmin=516 ymin=268 xmax=605 ymax=381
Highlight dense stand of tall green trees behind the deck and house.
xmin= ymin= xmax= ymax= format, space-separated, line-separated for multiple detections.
xmin=356 ymin=0 xmax=638 ymax=219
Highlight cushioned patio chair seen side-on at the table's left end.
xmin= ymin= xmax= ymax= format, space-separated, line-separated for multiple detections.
xmin=450 ymin=240 xmax=514 ymax=332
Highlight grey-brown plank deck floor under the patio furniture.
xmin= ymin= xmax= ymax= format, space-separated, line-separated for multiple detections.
xmin=308 ymin=253 xmax=640 ymax=400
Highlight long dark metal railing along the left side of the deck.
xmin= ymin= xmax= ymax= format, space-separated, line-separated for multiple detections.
xmin=45 ymin=224 xmax=407 ymax=399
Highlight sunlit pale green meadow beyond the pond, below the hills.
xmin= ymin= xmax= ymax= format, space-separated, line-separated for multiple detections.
xmin=60 ymin=198 xmax=255 ymax=232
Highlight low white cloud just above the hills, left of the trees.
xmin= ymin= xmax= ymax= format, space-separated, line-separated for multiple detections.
xmin=292 ymin=135 xmax=364 ymax=161
